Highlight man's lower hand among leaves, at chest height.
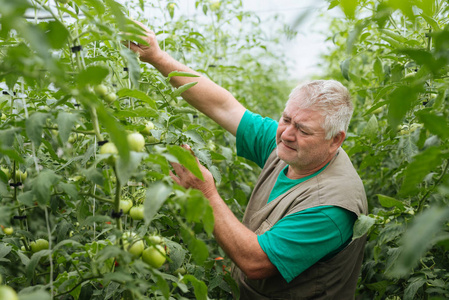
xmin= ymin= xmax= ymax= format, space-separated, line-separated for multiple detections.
xmin=170 ymin=145 xmax=218 ymax=199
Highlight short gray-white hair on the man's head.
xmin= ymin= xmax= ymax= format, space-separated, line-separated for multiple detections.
xmin=287 ymin=80 xmax=354 ymax=140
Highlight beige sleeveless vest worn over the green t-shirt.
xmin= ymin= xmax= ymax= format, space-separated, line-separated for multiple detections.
xmin=233 ymin=148 xmax=368 ymax=300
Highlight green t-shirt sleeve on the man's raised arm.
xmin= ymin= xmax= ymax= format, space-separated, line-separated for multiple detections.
xmin=236 ymin=110 xmax=278 ymax=168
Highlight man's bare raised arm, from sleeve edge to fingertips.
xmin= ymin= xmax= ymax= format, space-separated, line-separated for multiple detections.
xmin=129 ymin=21 xmax=246 ymax=135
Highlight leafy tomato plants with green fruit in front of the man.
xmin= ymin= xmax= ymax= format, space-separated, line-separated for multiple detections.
xmin=0 ymin=0 xmax=290 ymax=299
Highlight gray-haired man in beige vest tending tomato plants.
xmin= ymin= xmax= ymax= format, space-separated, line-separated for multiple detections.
xmin=129 ymin=19 xmax=367 ymax=299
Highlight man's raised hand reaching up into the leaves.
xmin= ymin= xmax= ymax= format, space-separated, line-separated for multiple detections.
xmin=125 ymin=20 xmax=164 ymax=64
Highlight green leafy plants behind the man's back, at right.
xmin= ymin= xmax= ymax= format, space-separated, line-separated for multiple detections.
xmin=323 ymin=0 xmax=449 ymax=299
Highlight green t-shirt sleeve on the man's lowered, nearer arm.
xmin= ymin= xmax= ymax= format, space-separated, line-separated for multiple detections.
xmin=258 ymin=206 xmax=356 ymax=282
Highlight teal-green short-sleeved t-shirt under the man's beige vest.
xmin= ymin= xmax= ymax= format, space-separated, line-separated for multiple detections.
xmin=237 ymin=111 xmax=356 ymax=282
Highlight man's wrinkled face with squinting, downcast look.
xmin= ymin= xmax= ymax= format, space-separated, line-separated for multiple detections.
xmin=276 ymin=101 xmax=338 ymax=173
